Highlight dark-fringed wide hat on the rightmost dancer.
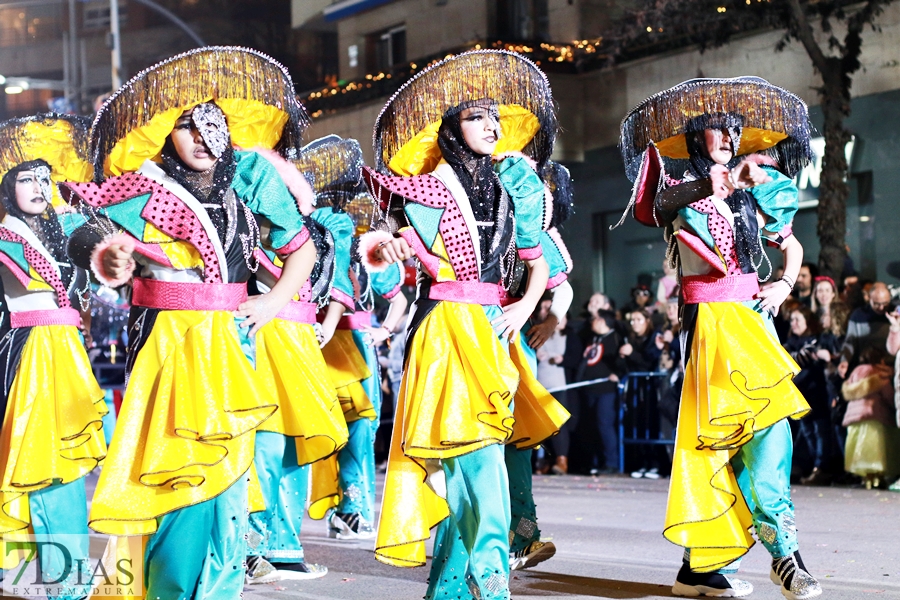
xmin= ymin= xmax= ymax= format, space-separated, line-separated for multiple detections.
xmin=619 ymin=77 xmax=811 ymax=180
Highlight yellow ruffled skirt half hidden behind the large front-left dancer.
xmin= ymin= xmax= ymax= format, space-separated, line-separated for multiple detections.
xmin=256 ymin=319 xmax=348 ymax=465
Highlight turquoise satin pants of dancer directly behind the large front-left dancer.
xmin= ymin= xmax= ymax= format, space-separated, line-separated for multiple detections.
xmin=247 ymin=431 xmax=309 ymax=563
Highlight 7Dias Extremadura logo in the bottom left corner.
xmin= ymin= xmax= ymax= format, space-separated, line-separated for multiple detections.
xmin=0 ymin=533 xmax=144 ymax=600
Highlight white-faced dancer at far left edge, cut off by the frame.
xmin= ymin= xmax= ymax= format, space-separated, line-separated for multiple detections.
xmin=0 ymin=114 xmax=106 ymax=598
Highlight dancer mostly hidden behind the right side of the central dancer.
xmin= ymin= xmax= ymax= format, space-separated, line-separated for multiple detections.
xmin=503 ymin=161 xmax=573 ymax=571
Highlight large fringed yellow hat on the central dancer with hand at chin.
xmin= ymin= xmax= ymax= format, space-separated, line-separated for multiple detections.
xmin=374 ymin=50 xmax=558 ymax=175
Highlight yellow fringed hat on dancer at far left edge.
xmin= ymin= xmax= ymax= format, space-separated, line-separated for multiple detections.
xmin=0 ymin=113 xmax=94 ymax=205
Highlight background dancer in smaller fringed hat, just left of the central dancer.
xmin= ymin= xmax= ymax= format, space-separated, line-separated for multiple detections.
xmin=301 ymin=136 xmax=407 ymax=540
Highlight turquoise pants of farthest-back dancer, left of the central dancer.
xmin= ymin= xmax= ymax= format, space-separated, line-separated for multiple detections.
xmin=337 ymin=331 xmax=381 ymax=523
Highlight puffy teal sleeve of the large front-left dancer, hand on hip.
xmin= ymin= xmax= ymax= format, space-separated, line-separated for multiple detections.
xmin=231 ymin=151 xmax=309 ymax=254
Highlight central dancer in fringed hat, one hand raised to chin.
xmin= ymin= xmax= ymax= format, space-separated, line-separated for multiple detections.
xmin=360 ymin=51 xmax=557 ymax=599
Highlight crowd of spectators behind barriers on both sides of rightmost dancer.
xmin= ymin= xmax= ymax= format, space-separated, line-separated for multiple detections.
xmin=524 ymin=264 xmax=900 ymax=490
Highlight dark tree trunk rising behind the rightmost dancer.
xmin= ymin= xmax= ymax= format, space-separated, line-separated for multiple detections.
xmin=816 ymin=62 xmax=850 ymax=281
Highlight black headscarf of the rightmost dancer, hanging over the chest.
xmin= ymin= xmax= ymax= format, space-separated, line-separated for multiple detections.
xmin=685 ymin=114 xmax=763 ymax=273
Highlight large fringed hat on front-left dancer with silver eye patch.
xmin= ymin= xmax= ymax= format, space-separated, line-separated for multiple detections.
xmin=91 ymin=46 xmax=309 ymax=175
